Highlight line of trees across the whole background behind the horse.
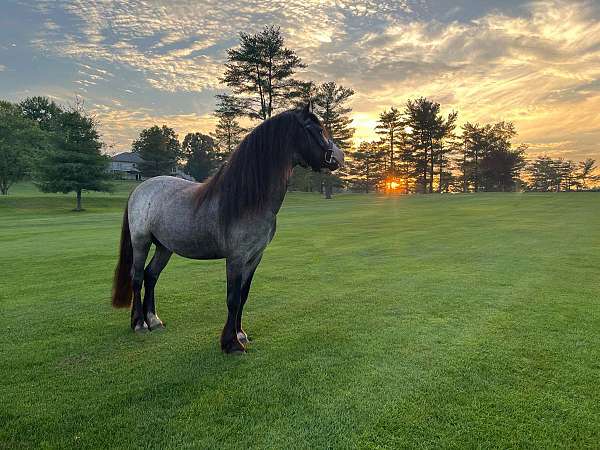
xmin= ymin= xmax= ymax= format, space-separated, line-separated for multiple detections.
xmin=0 ymin=26 xmax=600 ymax=209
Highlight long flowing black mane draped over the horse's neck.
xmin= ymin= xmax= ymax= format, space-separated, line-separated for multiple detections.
xmin=197 ymin=111 xmax=300 ymax=229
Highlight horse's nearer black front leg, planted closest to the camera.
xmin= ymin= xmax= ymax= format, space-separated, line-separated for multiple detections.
xmin=221 ymin=259 xmax=246 ymax=353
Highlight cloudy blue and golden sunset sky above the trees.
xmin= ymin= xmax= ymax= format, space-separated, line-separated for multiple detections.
xmin=0 ymin=0 xmax=600 ymax=160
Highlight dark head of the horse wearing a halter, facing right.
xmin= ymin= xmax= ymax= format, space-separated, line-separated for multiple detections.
xmin=294 ymin=103 xmax=344 ymax=172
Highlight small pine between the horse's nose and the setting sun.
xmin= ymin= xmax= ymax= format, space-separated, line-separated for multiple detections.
xmin=348 ymin=142 xmax=386 ymax=194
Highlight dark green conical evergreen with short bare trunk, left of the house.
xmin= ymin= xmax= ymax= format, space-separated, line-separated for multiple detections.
xmin=33 ymin=103 xmax=110 ymax=211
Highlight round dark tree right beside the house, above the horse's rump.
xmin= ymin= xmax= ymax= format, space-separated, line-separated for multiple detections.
xmin=132 ymin=125 xmax=181 ymax=177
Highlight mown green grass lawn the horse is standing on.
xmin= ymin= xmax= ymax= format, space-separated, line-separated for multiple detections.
xmin=0 ymin=185 xmax=600 ymax=449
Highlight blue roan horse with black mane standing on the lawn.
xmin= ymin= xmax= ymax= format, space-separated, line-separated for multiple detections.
xmin=112 ymin=105 xmax=344 ymax=353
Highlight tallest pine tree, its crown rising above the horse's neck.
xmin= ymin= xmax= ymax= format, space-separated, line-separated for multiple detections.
xmin=218 ymin=26 xmax=305 ymax=120
